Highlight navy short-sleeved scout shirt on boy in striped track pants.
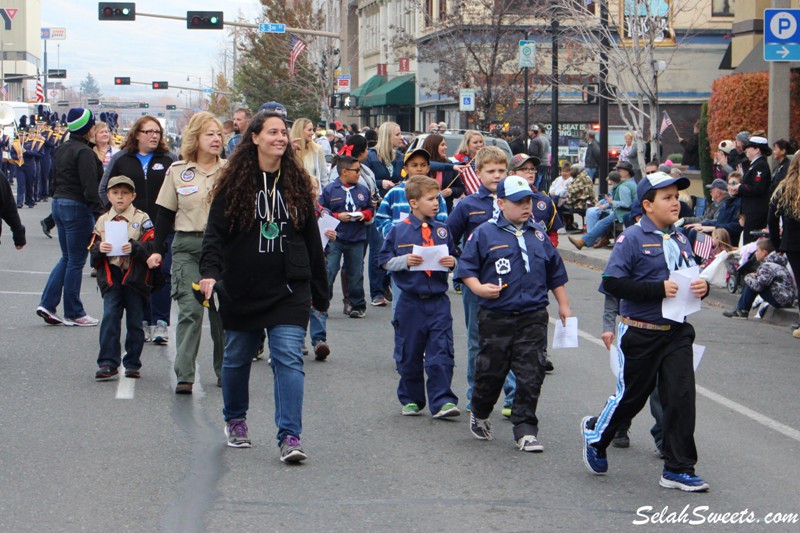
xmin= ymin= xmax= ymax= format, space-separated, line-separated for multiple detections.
xmin=603 ymin=216 xmax=695 ymax=324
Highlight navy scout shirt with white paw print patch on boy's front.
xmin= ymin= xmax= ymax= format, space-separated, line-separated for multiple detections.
xmin=453 ymin=212 xmax=567 ymax=313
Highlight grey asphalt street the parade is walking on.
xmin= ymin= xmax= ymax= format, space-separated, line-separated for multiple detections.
xmin=0 ymin=204 xmax=800 ymax=532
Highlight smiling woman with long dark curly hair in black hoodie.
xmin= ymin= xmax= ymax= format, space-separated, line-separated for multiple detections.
xmin=200 ymin=111 xmax=329 ymax=462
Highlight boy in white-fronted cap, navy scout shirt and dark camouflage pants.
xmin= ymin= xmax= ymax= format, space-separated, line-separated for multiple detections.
xmin=454 ymin=177 xmax=572 ymax=452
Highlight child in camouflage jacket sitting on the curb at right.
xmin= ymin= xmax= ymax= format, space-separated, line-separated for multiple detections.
xmin=722 ymin=239 xmax=795 ymax=320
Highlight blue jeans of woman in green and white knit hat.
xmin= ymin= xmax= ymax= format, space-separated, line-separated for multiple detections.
xmin=39 ymin=198 xmax=94 ymax=320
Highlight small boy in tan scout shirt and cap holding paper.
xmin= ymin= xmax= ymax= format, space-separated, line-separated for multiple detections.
xmin=89 ymin=176 xmax=163 ymax=381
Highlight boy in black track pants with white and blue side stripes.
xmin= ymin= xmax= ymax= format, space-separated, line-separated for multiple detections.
xmin=581 ymin=172 xmax=708 ymax=492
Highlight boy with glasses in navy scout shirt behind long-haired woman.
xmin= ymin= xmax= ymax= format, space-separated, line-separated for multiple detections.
xmin=319 ymin=156 xmax=372 ymax=318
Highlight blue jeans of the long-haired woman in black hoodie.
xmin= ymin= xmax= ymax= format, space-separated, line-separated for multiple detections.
xmin=222 ymin=326 xmax=306 ymax=444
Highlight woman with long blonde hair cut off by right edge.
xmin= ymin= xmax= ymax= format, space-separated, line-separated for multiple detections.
xmin=767 ymin=152 xmax=800 ymax=339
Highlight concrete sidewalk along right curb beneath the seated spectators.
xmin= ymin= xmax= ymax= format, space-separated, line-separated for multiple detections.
xmin=558 ymin=230 xmax=800 ymax=326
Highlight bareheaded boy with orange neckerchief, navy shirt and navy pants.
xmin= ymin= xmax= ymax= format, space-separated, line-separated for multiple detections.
xmin=378 ymin=176 xmax=461 ymax=418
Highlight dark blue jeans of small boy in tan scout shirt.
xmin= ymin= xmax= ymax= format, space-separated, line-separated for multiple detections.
xmin=97 ymin=266 xmax=146 ymax=370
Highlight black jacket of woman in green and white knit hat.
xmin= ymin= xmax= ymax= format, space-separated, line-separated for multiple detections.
xmin=52 ymin=135 xmax=105 ymax=217
